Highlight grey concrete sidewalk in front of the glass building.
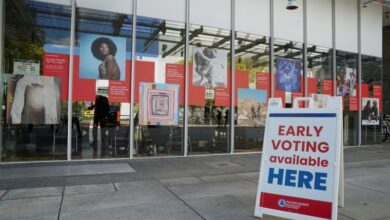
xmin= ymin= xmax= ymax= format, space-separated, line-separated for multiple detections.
xmin=0 ymin=144 xmax=390 ymax=220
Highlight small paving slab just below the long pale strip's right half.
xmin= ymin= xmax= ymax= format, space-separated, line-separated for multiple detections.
xmin=64 ymin=183 xmax=115 ymax=195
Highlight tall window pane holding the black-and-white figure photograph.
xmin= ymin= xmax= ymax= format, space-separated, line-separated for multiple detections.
xmin=188 ymin=25 xmax=231 ymax=154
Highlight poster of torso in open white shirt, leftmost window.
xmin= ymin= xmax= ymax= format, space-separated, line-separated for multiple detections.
xmin=7 ymin=75 xmax=61 ymax=124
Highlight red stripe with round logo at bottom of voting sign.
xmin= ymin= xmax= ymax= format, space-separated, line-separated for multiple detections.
xmin=260 ymin=193 xmax=332 ymax=219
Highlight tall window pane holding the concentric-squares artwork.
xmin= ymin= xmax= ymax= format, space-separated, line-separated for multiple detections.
xmin=133 ymin=17 xmax=185 ymax=157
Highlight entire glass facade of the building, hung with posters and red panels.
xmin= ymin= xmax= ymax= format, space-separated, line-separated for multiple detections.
xmin=0 ymin=0 xmax=383 ymax=162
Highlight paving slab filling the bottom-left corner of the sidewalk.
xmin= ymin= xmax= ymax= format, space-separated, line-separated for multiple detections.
xmin=0 ymin=196 xmax=61 ymax=220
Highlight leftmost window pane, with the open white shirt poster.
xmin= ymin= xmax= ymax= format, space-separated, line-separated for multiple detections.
xmin=0 ymin=0 xmax=71 ymax=161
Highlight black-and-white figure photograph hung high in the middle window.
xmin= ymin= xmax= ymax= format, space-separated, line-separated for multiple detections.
xmin=192 ymin=47 xmax=228 ymax=88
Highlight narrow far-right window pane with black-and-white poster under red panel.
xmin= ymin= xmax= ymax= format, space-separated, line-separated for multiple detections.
xmin=360 ymin=55 xmax=383 ymax=144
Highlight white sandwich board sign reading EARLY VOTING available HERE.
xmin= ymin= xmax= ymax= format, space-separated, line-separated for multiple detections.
xmin=255 ymin=97 xmax=343 ymax=219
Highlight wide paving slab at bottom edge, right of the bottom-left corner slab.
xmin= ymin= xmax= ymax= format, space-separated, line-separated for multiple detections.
xmin=59 ymin=201 xmax=202 ymax=220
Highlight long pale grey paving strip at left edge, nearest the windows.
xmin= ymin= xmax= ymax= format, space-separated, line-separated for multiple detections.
xmin=0 ymin=163 xmax=135 ymax=179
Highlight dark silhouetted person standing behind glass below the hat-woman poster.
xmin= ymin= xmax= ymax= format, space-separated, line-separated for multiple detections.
xmin=88 ymin=95 xmax=110 ymax=156
